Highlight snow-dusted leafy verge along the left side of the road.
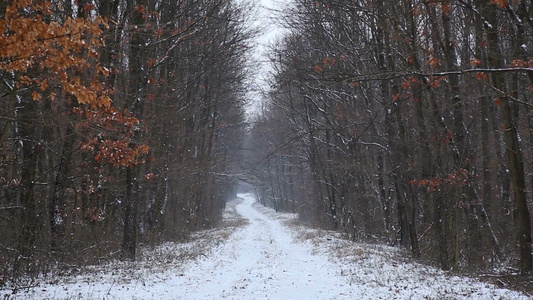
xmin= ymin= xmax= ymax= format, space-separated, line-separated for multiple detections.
xmin=0 ymin=201 xmax=247 ymax=300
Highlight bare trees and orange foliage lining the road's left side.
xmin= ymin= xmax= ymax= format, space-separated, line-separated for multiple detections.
xmin=0 ymin=0 xmax=252 ymax=282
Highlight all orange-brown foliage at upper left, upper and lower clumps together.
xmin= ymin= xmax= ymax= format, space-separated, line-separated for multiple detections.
xmin=0 ymin=0 xmax=148 ymax=166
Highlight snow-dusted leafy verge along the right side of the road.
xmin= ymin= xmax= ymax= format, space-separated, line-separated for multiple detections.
xmin=278 ymin=210 xmax=533 ymax=296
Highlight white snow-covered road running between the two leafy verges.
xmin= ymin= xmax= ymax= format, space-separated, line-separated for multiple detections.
xmin=177 ymin=195 xmax=351 ymax=299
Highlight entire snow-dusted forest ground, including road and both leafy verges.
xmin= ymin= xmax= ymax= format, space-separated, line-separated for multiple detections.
xmin=0 ymin=194 xmax=531 ymax=299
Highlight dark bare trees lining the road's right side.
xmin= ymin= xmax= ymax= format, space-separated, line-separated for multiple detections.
xmin=247 ymin=0 xmax=533 ymax=273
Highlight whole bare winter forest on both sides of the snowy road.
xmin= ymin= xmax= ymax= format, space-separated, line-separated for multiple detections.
xmin=0 ymin=0 xmax=533 ymax=287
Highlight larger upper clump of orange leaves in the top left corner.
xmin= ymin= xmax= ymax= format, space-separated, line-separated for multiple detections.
xmin=0 ymin=1 xmax=107 ymax=106
